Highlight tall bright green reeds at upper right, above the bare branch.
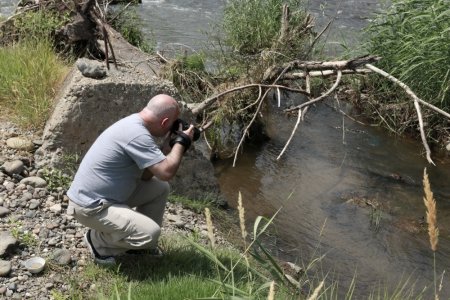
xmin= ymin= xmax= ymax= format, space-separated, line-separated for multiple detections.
xmin=366 ymin=0 xmax=450 ymax=108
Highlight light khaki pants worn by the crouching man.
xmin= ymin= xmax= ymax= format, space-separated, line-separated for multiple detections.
xmin=68 ymin=178 xmax=170 ymax=256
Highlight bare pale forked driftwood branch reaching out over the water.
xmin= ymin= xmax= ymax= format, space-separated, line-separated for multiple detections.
xmin=193 ymin=56 xmax=450 ymax=166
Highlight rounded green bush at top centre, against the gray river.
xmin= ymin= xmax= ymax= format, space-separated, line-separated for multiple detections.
xmin=222 ymin=0 xmax=305 ymax=54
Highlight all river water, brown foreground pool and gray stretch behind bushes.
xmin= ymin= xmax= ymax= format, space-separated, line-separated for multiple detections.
xmin=4 ymin=0 xmax=450 ymax=299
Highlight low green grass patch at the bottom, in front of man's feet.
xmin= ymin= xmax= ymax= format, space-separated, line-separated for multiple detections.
xmin=71 ymin=235 xmax=262 ymax=300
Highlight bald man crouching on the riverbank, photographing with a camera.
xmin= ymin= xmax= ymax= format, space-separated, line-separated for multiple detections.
xmin=67 ymin=94 xmax=193 ymax=265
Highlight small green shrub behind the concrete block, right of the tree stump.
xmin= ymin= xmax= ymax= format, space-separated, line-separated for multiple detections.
xmin=107 ymin=6 xmax=155 ymax=53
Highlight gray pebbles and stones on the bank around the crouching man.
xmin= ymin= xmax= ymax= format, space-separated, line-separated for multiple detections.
xmin=0 ymin=117 xmax=230 ymax=299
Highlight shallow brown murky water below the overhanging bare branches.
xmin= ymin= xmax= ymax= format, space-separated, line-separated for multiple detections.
xmin=214 ymin=96 xmax=450 ymax=297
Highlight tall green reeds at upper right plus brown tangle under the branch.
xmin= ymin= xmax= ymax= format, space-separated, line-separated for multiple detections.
xmin=364 ymin=0 xmax=450 ymax=139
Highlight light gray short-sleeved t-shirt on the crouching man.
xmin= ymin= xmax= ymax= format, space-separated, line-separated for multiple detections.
xmin=67 ymin=114 xmax=165 ymax=207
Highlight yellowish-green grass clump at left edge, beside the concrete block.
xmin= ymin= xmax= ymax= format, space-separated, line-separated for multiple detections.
xmin=0 ymin=38 xmax=68 ymax=128
